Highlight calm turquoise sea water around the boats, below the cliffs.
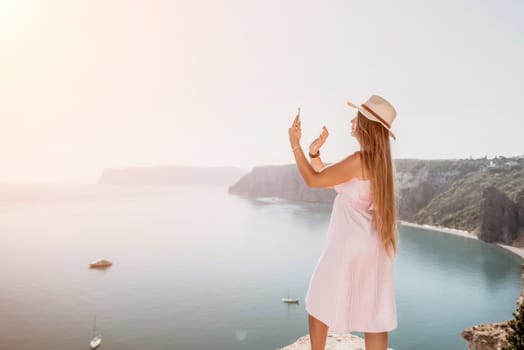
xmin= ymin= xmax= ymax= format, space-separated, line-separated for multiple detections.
xmin=0 ymin=185 xmax=521 ymax=350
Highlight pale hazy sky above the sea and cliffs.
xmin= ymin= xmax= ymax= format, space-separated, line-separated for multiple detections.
xmin=0 ymin=0 xmax=524 ymax=183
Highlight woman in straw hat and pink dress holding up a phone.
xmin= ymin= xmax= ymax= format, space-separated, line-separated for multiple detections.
xmin=289 ymin=95 xmax=398 ymax=350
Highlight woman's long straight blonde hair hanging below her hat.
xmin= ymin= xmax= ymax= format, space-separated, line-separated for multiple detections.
xmin=356 ymin=111 xmax=399 ymax=256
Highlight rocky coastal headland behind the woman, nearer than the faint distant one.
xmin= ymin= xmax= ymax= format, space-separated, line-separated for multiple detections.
xmin=228 ymin=157 xmax=524 ymax=247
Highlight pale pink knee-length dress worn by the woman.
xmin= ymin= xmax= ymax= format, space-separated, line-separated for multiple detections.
xmin=306 ymin=178 xmax=397 ymax=334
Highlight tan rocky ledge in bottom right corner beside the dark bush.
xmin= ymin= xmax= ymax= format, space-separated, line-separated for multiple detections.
xmin=462 ymin=264 xmax=524 ymax=350
